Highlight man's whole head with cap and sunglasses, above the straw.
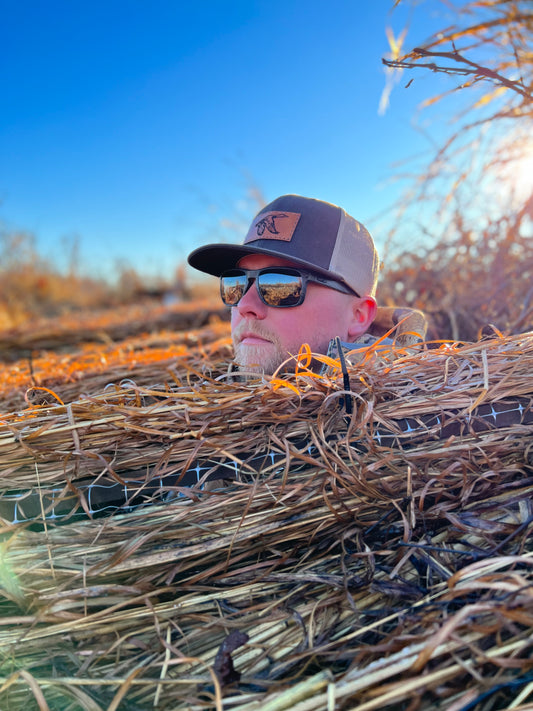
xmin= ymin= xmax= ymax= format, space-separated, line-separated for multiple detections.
xmin=189 ymin=195 xmax=378 ymax=373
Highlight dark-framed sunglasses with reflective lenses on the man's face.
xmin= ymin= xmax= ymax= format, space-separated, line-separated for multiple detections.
xmin=220 ymin=267 xmax=359 ymax=308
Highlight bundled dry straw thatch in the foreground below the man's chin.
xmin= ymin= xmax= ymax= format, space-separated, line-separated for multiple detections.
xmin=0 ymin=334 xmax=533 ymax=711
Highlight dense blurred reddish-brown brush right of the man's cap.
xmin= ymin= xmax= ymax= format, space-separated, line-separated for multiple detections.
xmin=378 ymin=224 xmax=533 ymax=341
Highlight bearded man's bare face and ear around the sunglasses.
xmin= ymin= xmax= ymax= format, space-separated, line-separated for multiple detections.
xmin=231 ymin=254 xmax=366 ymax=375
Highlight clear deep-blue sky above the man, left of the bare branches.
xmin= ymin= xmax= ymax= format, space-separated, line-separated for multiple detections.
xmin=0 ymin=0 xmax=456 ymax=284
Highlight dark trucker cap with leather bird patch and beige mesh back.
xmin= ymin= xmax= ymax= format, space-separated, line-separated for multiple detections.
xmin=188 ymin=195 xmax=379 ymax=296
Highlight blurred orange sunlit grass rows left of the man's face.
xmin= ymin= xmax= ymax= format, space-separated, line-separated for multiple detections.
xmin=0 ymin=301 xmax=231 ymax=413
